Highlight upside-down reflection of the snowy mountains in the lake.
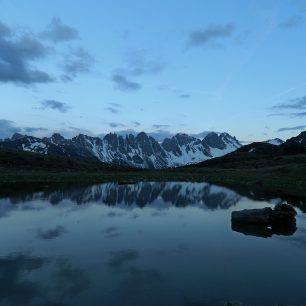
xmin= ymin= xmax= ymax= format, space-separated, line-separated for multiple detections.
xmin=2 ymin=182 xmax=240 ymax=209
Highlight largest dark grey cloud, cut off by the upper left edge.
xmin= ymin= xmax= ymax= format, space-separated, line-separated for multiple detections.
xmin=0 ymin=23 xmax=54 ymax=85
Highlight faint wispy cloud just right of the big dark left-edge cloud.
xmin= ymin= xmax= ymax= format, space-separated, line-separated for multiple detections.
xmin=61 ymin=47 xmax=95 ymax=82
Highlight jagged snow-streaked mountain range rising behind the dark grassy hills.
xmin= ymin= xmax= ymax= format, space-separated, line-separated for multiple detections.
xmin=0 ymin=132 xmax=242 ymax=169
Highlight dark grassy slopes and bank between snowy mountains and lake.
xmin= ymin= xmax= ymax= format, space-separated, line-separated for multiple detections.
xmin=0 ymin=149 xmax=306 ymax=197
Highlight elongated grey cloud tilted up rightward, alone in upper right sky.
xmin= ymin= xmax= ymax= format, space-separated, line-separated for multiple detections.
xmin=187 ymin=23 xmax=235 ymax=47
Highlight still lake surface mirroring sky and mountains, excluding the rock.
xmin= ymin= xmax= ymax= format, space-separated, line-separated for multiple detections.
xmin=0 ymin=183 xmax=306 ymax=306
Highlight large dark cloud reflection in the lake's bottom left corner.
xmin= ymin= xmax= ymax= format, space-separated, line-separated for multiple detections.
xmin=0 ymin=254 xmax=90 ymax=306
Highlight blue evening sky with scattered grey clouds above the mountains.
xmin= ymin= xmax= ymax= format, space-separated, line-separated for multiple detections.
xmin=0 ymin=0 xmax=306 ymax=141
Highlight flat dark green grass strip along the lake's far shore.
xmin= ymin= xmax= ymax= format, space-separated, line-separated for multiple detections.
xmin=0 ymin=165 xmax=306 ymax=198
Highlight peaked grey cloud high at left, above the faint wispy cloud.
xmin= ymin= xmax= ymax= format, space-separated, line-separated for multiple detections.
xmin=40 ymin=18 xmax=79 ymax=43
